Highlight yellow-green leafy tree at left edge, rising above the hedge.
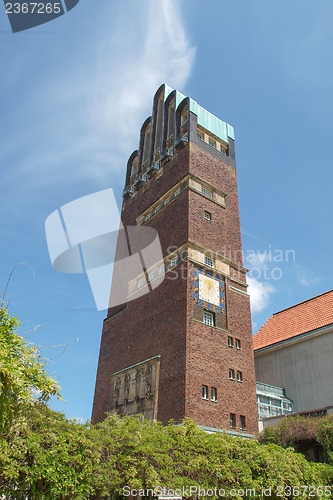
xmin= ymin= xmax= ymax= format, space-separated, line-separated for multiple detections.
xmin=0 ymin=306 xmax=61 ymax=436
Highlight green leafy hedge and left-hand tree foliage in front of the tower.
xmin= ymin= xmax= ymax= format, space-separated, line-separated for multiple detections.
xmin=0 ymin=309 xmax=333 ymax=500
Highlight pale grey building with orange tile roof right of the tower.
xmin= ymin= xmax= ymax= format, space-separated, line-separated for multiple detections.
xmin=253 ymin=290 xmax=333 ymax=416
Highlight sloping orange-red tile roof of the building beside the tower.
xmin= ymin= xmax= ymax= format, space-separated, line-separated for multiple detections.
xmin=253 ymin=290 xmax=333 ymax=350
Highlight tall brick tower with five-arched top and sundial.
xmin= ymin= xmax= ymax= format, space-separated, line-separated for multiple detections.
xmin=93 ymin=85 xmax=257 ymax=435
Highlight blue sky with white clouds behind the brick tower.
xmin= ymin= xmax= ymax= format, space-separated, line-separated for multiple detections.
xmin=0 ymin=0 xmax=333 ymax=419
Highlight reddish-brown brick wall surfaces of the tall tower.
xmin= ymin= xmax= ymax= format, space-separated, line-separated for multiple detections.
xmin=93 ymin=137 xmax=257 ymax=433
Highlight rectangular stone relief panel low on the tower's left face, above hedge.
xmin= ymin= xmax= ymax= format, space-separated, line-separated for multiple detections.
xmin=109 ymin=356 xmax=160 ymax=420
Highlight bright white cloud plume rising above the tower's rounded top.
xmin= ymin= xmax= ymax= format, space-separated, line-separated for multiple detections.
xmin=90 ymin=0 xmax=195 ymax=174
